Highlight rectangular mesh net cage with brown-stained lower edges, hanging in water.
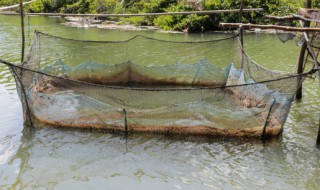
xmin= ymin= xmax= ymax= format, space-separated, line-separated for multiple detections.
xmin=2 ymin=31 xmax=306 ymax=137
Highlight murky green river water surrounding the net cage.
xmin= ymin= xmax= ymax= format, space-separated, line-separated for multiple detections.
xmin=0 ymin=16 xmax=320 ymax=190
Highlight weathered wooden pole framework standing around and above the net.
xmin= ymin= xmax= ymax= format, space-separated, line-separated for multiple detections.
xmin=0 ymin=0 xmax=320 ymax=142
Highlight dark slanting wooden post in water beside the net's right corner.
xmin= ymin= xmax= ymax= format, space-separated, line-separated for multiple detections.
xmin=296 ymin=0 xmax=312 ymax=100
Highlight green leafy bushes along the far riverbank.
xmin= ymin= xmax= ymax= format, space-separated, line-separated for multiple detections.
xmin=0 ymin=0 xmax=320 ymax=32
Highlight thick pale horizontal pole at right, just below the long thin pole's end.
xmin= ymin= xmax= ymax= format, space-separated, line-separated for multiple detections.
xmin=220 ymin=23 xmax=320 ymax=32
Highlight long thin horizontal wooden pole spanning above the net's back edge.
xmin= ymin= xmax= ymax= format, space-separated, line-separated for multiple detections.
xmin=0 ymin=8 xmax=263 ymax=17
